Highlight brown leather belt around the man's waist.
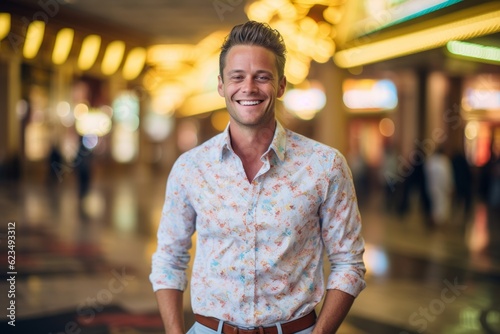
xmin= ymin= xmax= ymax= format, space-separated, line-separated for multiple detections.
xmin=194 ymin=311 xmax=316 ymax=334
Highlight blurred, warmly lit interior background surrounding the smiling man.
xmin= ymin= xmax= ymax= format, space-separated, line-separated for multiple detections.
xmin=0 ymin=0 xmax=500 ymax=334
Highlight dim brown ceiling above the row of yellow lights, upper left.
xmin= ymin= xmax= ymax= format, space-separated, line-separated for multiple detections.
xmin=6 ymin=0 xmax=247 ymax=44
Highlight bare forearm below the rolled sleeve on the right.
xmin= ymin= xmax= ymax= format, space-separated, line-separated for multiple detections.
xmin=313 ymin=290 xmax=354 ymax=334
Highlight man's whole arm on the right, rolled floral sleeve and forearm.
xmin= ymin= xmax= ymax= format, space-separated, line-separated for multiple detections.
xmin=314 ymin=155 xmax=365 ymax=334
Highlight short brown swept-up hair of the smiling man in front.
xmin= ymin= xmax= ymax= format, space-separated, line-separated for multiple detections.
xmin=219 ymin=21 xmax=286 ymax=79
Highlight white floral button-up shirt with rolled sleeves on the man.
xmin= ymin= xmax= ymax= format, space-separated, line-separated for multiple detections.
xmin=150 ymin=122 xmax=365 ymax=326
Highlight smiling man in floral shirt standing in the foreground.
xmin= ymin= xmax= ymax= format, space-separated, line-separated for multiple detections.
xmin=150 ymin=21 xmax=365 ymax=334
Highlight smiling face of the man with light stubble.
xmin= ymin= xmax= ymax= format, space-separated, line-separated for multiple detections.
xmin=218 ymin=45 xmax=286 ymax=128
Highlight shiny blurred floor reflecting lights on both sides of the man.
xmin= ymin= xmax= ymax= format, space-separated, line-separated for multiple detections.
xmin=0 ymin=165 xmax=500 ymax=334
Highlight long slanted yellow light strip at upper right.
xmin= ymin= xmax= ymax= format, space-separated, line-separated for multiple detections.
xmin=334 ymin=4 xmax=500 ymax=68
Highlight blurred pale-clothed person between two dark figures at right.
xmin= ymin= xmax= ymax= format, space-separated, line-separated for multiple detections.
xmin=424 ymin=147 xmax=453 ymax=225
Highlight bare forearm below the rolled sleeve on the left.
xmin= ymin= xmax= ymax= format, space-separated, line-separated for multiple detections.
xmin=156 ymin=289 xmax=186 ymax=334
